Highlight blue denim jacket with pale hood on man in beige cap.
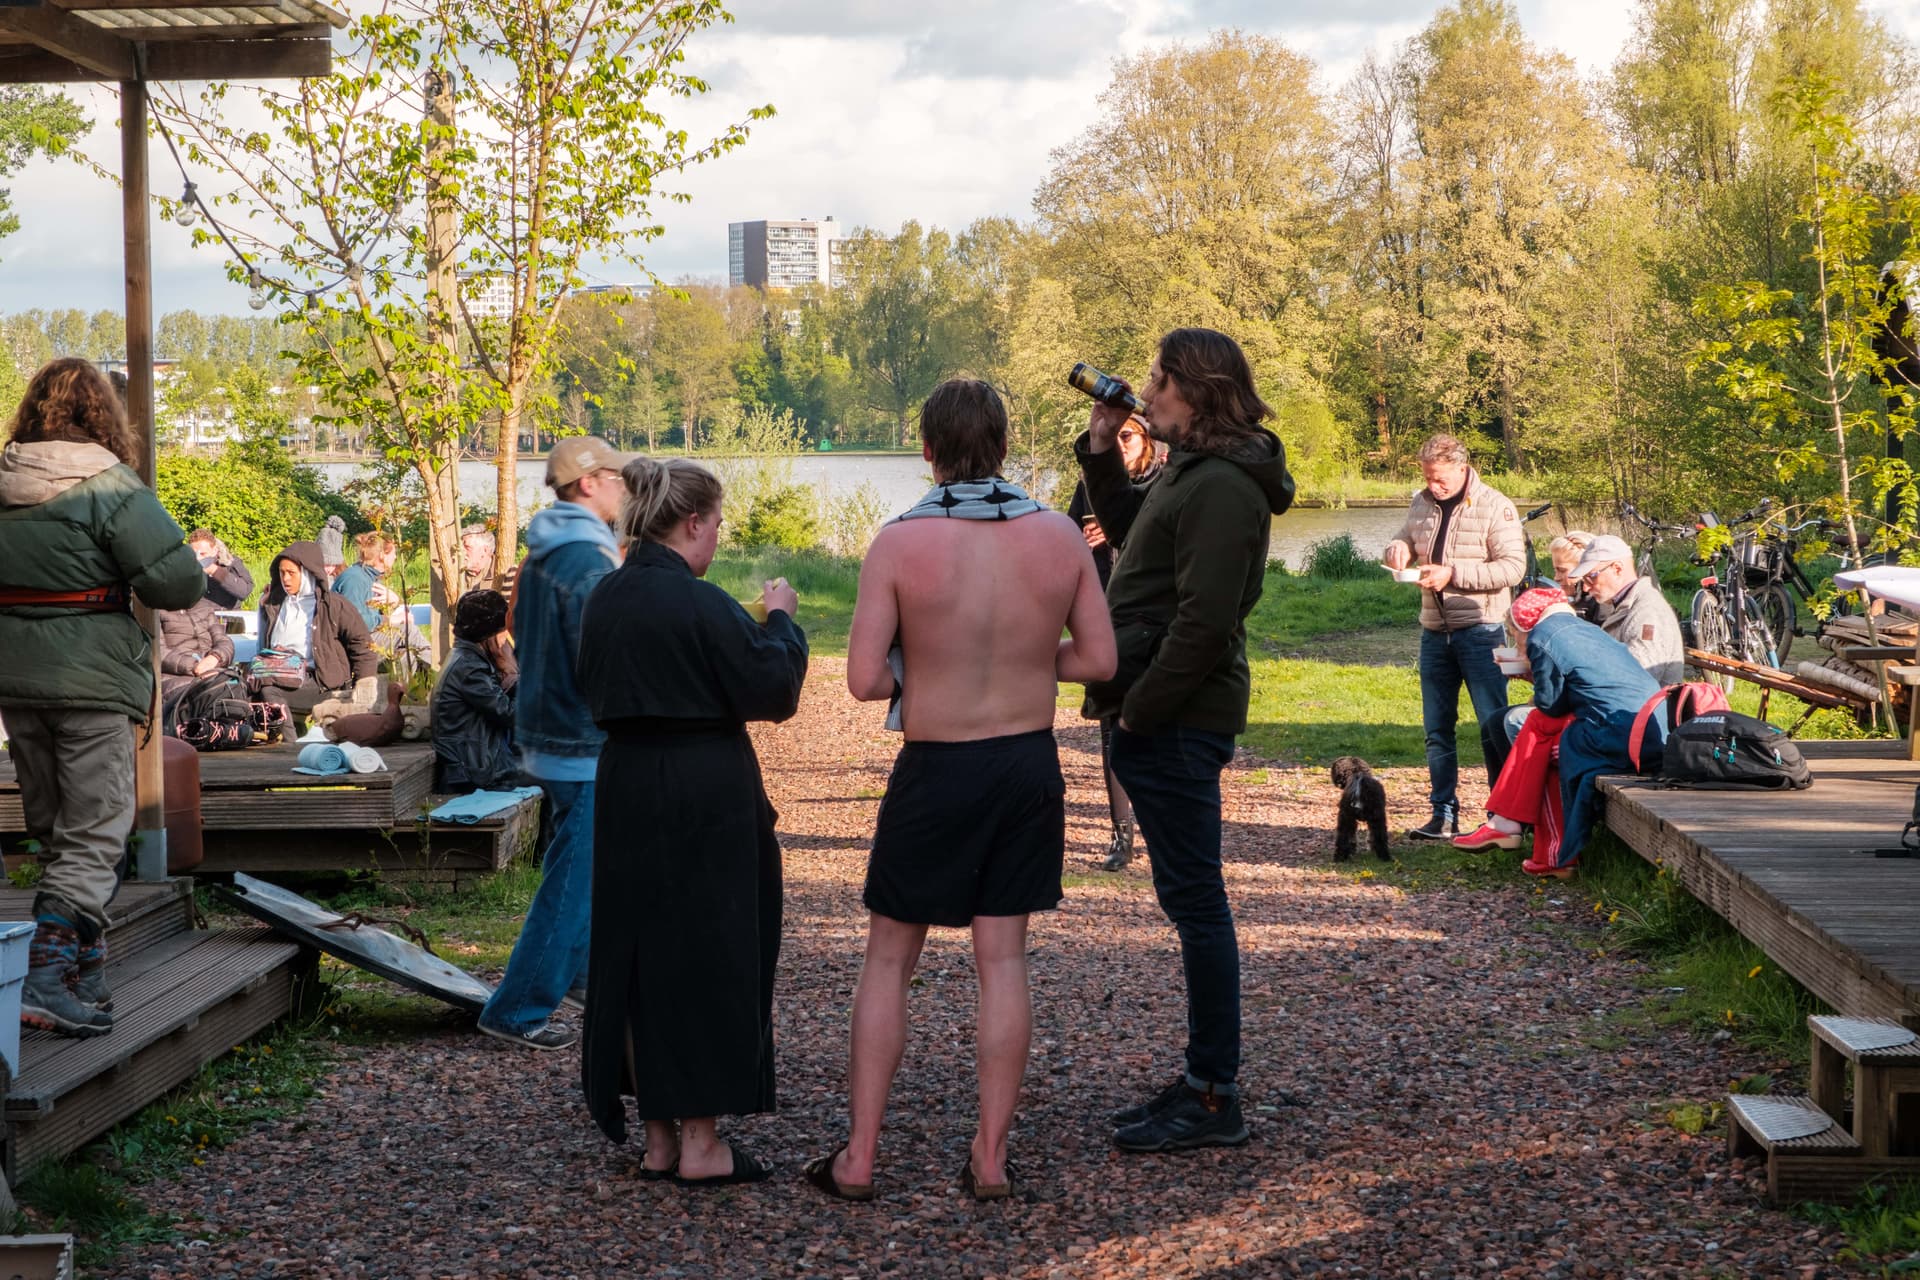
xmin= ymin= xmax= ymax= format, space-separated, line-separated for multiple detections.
xmin=513 ymin=503 xmax=616 ymax=777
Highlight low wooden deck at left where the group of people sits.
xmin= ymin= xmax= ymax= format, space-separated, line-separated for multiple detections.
xmin=0 ymin=743 xmax=540 ymax=887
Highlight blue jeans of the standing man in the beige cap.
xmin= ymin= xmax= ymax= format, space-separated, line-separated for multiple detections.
xmin=480 ymin=779 xmax=593 ymax=1036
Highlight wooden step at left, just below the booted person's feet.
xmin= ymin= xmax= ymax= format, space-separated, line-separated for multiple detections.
xmin=6 ymin=927 xmax=311 ymax=1178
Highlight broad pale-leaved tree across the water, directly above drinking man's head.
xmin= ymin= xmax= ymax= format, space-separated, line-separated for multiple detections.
xmin=1033 ymin=31 xmax=1334 ymax=395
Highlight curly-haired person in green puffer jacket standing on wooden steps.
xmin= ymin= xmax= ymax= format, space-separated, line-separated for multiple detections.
xmin=0 ymin=357 xmax=207 ymax=1036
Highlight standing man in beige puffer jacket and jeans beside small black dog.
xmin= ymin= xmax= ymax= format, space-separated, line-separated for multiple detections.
xmin=1386 ymin=436 xmax=1526 ymax=841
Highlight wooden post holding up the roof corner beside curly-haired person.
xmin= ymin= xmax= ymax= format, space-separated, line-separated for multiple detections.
xmin=121 ymin=81 xmax=167 ymax=875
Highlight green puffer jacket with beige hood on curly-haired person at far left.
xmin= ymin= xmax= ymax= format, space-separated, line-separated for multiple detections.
xmin=0 ymin=439 xmax=207 ymax=722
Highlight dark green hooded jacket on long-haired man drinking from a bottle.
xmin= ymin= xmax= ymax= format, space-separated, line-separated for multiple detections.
xmin=1073 ymin=428 xmax=1294 ymax=733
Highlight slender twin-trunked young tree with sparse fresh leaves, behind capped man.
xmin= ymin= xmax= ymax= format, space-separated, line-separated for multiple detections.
xmin=157 ymin=0 xmax=772 ymax=625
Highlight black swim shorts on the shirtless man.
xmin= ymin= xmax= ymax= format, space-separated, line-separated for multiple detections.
xmin=864 ymin=729 xmax=1068 ymax=927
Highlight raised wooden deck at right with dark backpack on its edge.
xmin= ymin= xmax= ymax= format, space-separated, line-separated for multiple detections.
xmin=1601 ymin=741 xmax=1920 ymax=1027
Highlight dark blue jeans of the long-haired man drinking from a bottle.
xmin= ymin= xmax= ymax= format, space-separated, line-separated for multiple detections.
xmin=1114 ymin=725 xmax=1240 ymax=1084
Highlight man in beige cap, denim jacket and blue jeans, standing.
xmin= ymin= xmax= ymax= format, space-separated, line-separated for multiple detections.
xmin=480 ymin=436 xmax=630 ymax=1050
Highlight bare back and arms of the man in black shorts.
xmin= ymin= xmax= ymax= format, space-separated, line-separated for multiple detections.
xmin=847 ymin=510 xmax=1116 ymax=743
